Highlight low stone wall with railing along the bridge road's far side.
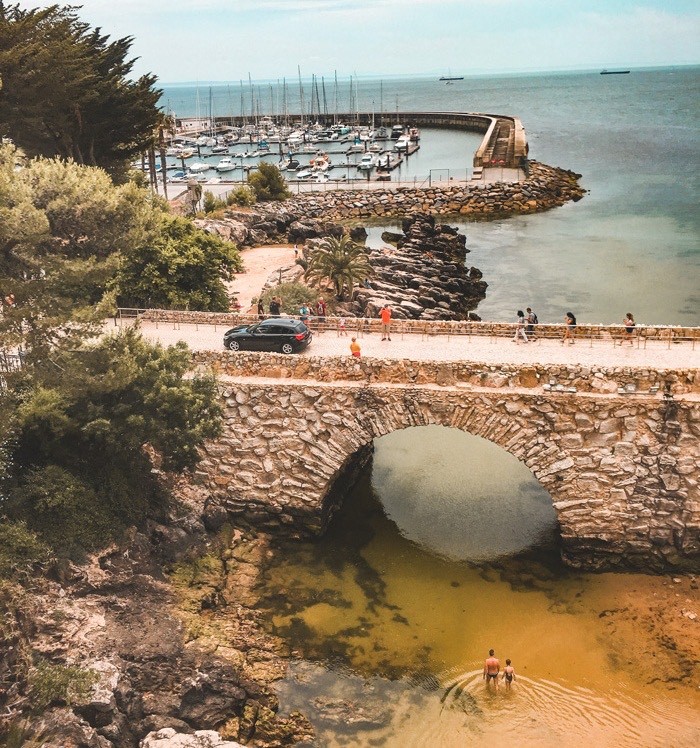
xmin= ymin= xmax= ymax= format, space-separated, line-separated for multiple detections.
xmin=114 ymin=308 xmax=700 ymax=350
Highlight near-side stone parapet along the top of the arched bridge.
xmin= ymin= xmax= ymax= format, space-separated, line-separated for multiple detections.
xmin=192 ymin=351 xmax=700 ymax=398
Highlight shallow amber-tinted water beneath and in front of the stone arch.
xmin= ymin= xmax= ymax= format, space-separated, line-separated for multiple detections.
xmin=261 ymin=427 xmax=700 ymax=747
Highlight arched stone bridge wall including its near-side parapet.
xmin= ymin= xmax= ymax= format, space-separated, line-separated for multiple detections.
xmin=195 ymin=352 xmax=700 ymax=567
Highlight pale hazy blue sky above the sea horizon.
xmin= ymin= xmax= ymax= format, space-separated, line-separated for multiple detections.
xmin=37 ymin=0 xmax=700 ymax=82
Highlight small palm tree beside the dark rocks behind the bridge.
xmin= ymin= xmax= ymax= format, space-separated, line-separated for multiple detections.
xmin=304 ymin=236 xmax=374 ymax=299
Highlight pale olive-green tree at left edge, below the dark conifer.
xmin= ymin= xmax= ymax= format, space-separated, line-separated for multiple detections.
xmin=0 ymin=145 xmax=162 ymax=362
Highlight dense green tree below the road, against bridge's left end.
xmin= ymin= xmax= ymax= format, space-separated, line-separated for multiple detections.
xmin=0 ymin=329 xmax=221 ymax=555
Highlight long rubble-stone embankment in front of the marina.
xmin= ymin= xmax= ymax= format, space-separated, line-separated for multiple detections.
xmin=195 ymin=161 xmax=585 ymax=247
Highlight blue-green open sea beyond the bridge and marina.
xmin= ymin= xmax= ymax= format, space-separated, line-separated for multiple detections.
xmin=161 ymin=67 xmax=700 ymax=325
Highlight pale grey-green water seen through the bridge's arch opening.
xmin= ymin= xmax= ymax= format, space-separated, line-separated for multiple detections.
xmin=372 ymin=426 xmax=556 ymax=561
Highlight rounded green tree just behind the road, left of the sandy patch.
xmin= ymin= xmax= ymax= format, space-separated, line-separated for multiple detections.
xmin=116 ymin=215 xmax=242 ymax=312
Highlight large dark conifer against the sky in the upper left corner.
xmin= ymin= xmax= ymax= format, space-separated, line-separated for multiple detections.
xmin=0 ymin=3 xmax=161 ymax=178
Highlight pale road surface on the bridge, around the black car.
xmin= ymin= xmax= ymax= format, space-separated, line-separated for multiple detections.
xmin=116 ymin=321 xmax=700 ymax=369
